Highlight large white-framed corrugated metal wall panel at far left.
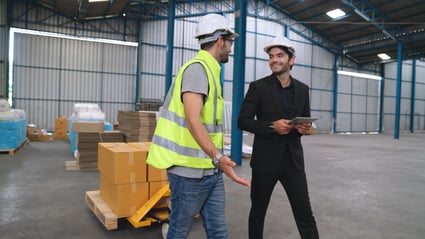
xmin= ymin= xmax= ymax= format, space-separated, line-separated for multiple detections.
xmin=13 ymin=33 xmax=137 ymax=130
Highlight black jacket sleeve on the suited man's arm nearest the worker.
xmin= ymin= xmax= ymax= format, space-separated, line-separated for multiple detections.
xmin=238 ymin=82 xmax=273 ymax=138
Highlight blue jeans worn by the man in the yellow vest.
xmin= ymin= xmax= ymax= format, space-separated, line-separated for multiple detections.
xmin=167 ymin=172 xmax=228 ymax=239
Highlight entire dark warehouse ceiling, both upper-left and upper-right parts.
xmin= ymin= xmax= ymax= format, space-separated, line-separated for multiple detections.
xmin=36 ymin=0 xmax=425 ymax=65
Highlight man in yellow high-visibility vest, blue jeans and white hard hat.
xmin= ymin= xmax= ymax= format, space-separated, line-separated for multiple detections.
xmin=147 ymin=14 xmax=250 ymax=239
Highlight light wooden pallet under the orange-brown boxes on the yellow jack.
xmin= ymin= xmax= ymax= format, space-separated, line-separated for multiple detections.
xmin=85 ymin=190 xmax=118 ymax=230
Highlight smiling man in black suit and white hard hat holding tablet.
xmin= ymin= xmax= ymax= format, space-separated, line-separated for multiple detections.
xmin=238 ymin=37 xmax=319 ymax=239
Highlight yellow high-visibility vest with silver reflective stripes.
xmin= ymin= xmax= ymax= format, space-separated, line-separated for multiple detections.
xmin=147 ymin=50 xmax=224 ymax=169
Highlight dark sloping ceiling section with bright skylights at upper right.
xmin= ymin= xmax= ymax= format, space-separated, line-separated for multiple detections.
xmin=271 ymin=0 xmax=425 ymax=64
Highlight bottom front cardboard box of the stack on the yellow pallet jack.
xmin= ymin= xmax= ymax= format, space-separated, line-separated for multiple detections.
xmin=100 ymin=173 xmax=148 ymax=217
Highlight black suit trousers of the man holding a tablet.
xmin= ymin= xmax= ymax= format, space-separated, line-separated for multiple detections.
xmin=249 ymin=158 xmax=319 ymax=239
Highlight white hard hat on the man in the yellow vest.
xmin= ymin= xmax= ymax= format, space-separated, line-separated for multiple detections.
xmin=195 ymin=13 xmax=239 ymax=44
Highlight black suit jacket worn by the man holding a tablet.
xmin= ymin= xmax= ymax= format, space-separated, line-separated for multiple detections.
xmin=238 ymin=74 xmax=310 ymax=171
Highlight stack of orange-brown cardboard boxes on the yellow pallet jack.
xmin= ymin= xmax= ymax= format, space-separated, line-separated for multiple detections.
xmin=98 ymin=142 xmax=168 ymax=217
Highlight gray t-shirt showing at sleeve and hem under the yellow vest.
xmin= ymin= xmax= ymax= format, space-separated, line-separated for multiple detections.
xmin=167 ymin=63 xmax=218 ymax=178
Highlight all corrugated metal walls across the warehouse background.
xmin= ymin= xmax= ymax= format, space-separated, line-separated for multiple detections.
xmin=5 ymin=0 xmax=425 ymax=132
